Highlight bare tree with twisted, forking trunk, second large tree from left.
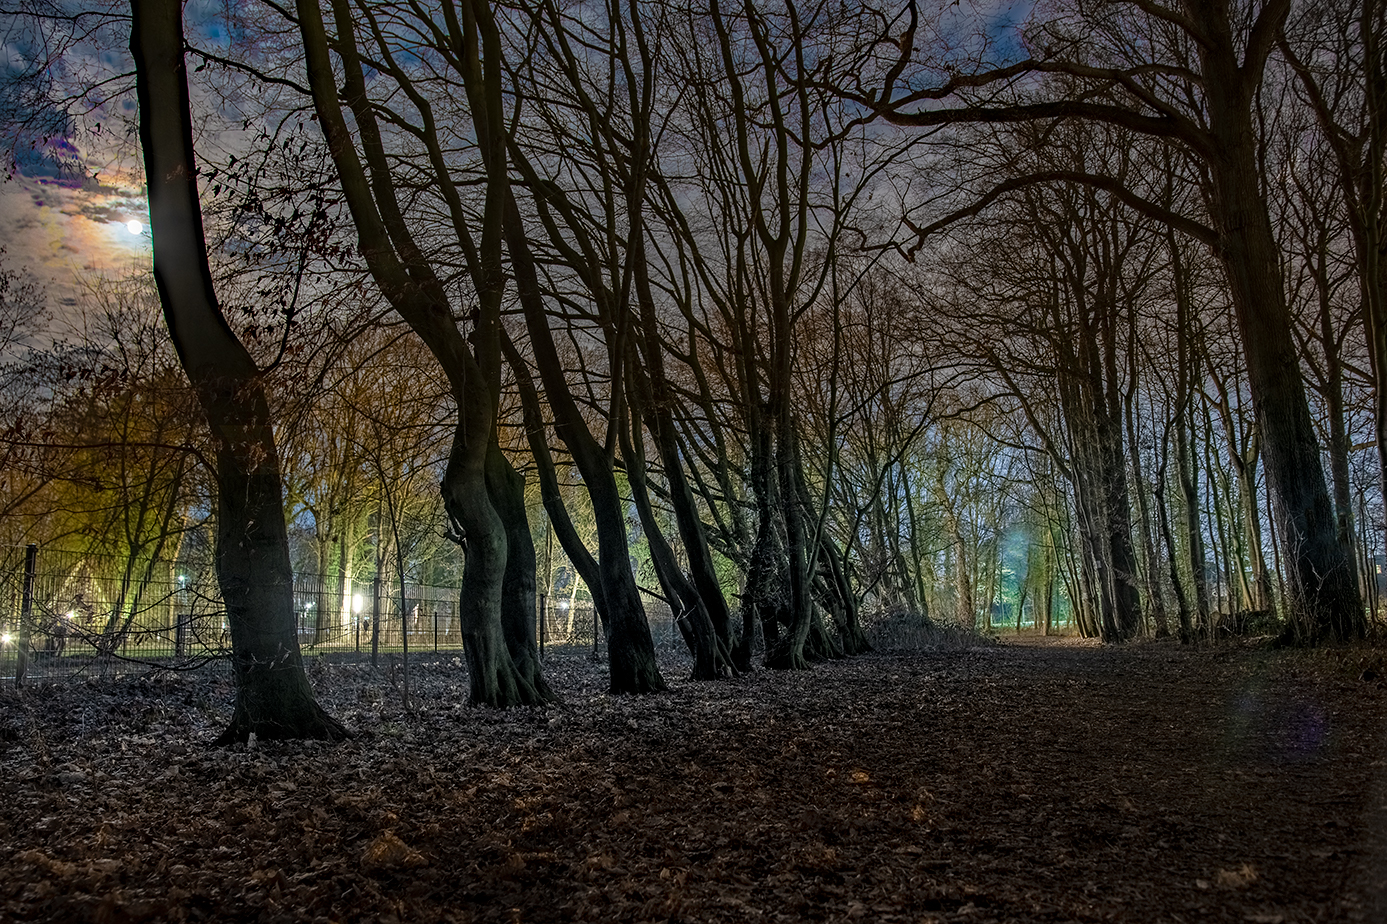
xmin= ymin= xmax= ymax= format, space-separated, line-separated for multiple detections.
xmin=297 ymin=0 xmax=552 ymax=705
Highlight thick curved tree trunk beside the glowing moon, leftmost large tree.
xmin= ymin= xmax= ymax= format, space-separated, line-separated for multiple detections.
xmin=130 ymin=0 xmax=347 ymax=744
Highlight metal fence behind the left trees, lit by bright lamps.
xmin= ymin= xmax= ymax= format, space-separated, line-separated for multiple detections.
xmin=0 ymin=547 xmax=675 ymax=680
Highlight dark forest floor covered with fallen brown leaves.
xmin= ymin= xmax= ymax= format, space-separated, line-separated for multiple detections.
xmin=0 ymin=629 xmax=1387 ymax=924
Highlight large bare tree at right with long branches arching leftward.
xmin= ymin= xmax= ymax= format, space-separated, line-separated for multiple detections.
xmin=847 ymin=0 xmax=1365 ymax=642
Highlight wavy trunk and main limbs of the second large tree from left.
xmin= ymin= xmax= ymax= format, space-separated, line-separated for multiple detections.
xmin=295 ymin=0 xmax=541 ymax=706
